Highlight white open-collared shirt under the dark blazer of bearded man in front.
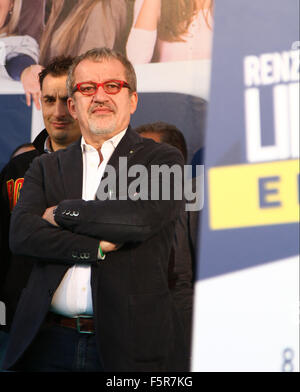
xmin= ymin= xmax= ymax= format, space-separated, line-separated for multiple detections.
xmin=50 ymin=129 xmax=126 ymax=317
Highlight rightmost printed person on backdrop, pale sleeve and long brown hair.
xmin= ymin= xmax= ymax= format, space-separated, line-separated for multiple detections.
xmin=126 ymin=0 xmax=212 ymax=64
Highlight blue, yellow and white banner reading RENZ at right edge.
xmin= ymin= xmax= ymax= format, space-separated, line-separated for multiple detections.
xmin=192 ymin=0 xmax=299 ymax=371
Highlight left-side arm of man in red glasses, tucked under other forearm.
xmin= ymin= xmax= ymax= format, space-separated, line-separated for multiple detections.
xmin=9 ymin=160 xmax=117 ymax=264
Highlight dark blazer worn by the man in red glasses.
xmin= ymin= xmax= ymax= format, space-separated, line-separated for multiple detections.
xmin=3 ymin=127 xmax=187 ymax=371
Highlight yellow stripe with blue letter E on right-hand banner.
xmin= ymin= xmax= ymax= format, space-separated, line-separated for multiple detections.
xmin=208 ymin=160 xmax=299 ymax=230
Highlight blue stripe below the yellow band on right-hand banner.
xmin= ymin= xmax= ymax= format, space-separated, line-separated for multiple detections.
xmin=196 ymin=205 xmax=299 ymax=280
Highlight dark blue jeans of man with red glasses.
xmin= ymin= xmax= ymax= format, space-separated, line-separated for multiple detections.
xmin=16 ymin=324 xmax=103 ymax=372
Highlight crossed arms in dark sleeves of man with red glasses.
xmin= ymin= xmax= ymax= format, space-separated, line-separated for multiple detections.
xmin=10 ymin=149 xmax=182 ymax=264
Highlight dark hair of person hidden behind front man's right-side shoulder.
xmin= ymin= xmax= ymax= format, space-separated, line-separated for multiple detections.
xmin=135 ymin=121 xmax=188 ymax=162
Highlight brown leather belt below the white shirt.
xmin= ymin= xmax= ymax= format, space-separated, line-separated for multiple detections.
xmin=46 ymin=312 xmax=95 ymax=333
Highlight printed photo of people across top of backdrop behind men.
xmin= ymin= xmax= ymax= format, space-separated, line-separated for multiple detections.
xmin=0 ymin=0 xmax=213 ymax=104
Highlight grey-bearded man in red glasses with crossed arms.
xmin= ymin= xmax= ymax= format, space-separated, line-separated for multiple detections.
xmin=3 ymin=48 xmax=188 ymax=371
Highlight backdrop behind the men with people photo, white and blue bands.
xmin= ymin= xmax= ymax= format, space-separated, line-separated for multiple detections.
xmin=0 ymin=0 xmax=214 ymax=170
